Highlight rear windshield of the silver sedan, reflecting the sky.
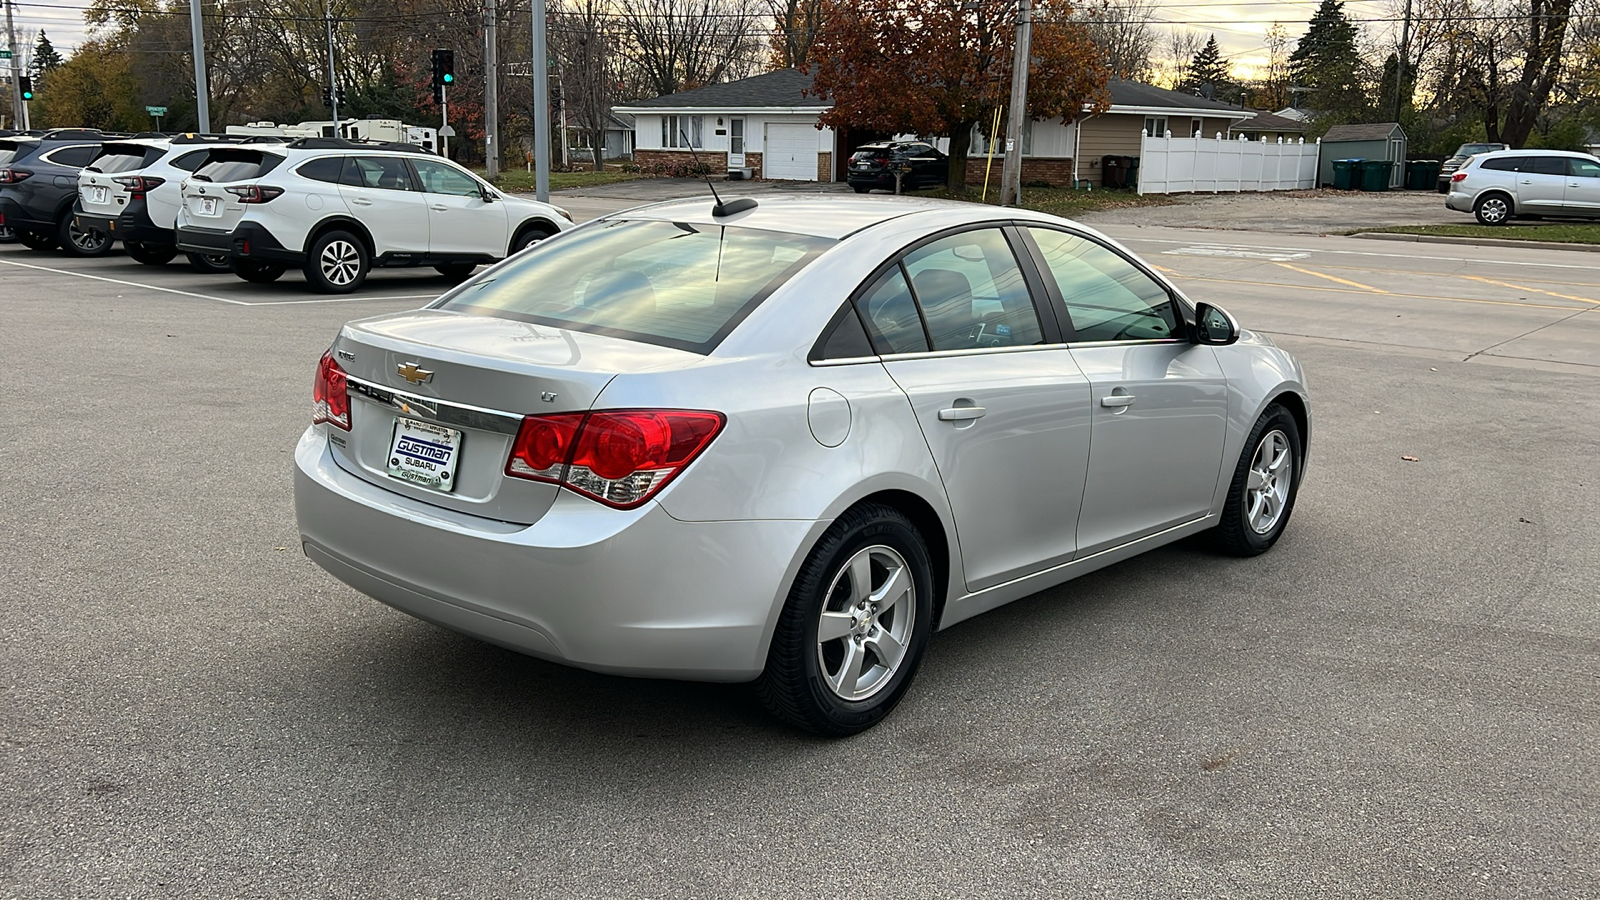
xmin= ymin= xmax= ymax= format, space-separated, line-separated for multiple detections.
xmin=438 ymin=221 xmax=834 ymax=354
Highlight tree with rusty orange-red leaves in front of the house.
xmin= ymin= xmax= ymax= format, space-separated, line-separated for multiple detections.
xmin=810 ymin=0 xmax=1110 ymax=191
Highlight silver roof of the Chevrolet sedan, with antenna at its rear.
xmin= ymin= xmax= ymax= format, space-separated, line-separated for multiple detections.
xmin=602 ymin=192 xmax=1059 ymax=240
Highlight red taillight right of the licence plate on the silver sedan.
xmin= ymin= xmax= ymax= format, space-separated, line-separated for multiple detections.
xmin=506 ymin=410 xmax=726 ymax=509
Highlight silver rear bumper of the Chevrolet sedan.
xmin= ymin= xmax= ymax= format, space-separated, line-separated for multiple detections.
xmin=294 ymin=426 xmax=814 ymax=681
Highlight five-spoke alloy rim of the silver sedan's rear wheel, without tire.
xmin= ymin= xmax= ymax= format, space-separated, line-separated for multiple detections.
xmin=816 ymin=544 xmax=917 ymax=700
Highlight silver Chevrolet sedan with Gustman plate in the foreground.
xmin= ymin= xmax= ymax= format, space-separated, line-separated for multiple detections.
xmin=294 ymin=197 xmax=1310 ymax=735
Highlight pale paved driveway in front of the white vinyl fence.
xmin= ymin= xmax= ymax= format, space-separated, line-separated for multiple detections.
xmin=1075 ymin=189 xmax=1472 ymax=234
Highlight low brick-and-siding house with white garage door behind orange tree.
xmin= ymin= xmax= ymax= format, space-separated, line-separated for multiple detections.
xmin=616 ymin=69 xmax=1254 ymax=184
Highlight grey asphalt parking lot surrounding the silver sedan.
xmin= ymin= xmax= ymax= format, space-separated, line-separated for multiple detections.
xmin=0 ymin=212 xmax=1600 ymax=898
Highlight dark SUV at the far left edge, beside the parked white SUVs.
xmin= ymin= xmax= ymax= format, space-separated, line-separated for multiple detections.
xmin=0 ymin=128 xmax=126 ymax=256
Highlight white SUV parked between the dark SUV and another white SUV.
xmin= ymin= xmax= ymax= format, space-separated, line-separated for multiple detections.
xmin=74 ymin=135 xmax=282 ymax=272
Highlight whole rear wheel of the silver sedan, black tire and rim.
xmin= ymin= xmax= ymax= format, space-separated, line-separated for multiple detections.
xmin=755 ymin=503 xmax=933 ymax=737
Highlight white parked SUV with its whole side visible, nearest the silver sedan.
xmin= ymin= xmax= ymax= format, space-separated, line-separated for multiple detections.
xmin=178 ymin=138 xmax=571 ymax=293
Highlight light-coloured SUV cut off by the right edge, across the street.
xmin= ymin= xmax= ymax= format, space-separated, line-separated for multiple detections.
xmin=1445 ymin=151 xmax=1600 ymax=224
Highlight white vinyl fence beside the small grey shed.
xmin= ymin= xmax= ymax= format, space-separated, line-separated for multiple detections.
xmin=1138 ymin=131 xmax=1322 ymax=194
